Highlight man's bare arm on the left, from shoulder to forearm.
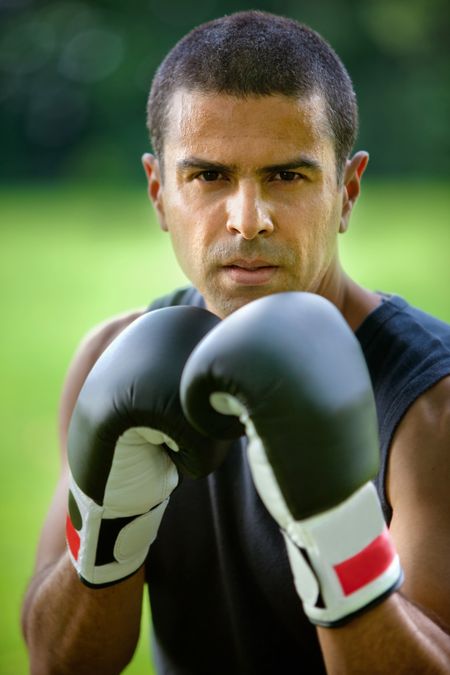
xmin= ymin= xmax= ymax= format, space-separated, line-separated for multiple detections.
xmin=22 ymin=312 xmax=144 ymax=675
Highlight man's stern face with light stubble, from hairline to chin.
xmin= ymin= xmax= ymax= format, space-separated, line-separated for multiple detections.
xmin=149 ymin=91 xmax=350 ymax=317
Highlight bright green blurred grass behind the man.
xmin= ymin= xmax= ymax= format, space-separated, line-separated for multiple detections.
xmin=0 ymin=181 xmax=450 ymax=675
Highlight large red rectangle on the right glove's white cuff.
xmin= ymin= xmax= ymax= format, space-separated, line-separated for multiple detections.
xmin=334 ymin=528 xmax=396 ymax=595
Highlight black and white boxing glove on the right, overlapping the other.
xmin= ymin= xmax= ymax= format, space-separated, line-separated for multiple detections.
xmin=181 ymin=293 xmax=402 ymax=626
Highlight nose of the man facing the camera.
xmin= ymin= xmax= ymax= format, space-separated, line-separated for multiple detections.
xmin=227 ymin=181 xmax=274 ymax=240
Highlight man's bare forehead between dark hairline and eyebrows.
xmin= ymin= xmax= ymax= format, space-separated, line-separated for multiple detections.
xmin=165 ymin=90 xmax=334 ymax=163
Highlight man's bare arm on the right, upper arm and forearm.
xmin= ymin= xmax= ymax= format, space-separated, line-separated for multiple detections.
xmin=319 ymin=378 xmax=450 ymax=675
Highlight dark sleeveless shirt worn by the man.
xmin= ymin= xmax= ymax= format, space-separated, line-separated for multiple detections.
xmin=146 ymin=288 xmax=450 ymax=675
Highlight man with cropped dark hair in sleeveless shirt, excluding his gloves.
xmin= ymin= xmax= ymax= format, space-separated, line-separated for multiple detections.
xmin=23 ymin=12 xmax=450 ymax=675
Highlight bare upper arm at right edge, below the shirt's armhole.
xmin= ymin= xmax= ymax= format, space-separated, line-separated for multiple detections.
xmin=388 ymin=378 xmax=450 ymax=628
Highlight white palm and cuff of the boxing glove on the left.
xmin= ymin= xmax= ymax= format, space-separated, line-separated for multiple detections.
xmin=67 ymin=427 xmax=178 ymax=586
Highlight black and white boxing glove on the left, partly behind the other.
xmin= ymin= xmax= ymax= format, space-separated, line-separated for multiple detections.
xmin=66 ymin=307 xmax=226 ymax=587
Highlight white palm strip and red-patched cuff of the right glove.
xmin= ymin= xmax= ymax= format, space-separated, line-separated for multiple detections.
xmin=211 ymin=392 xmax=402 ymax=626
